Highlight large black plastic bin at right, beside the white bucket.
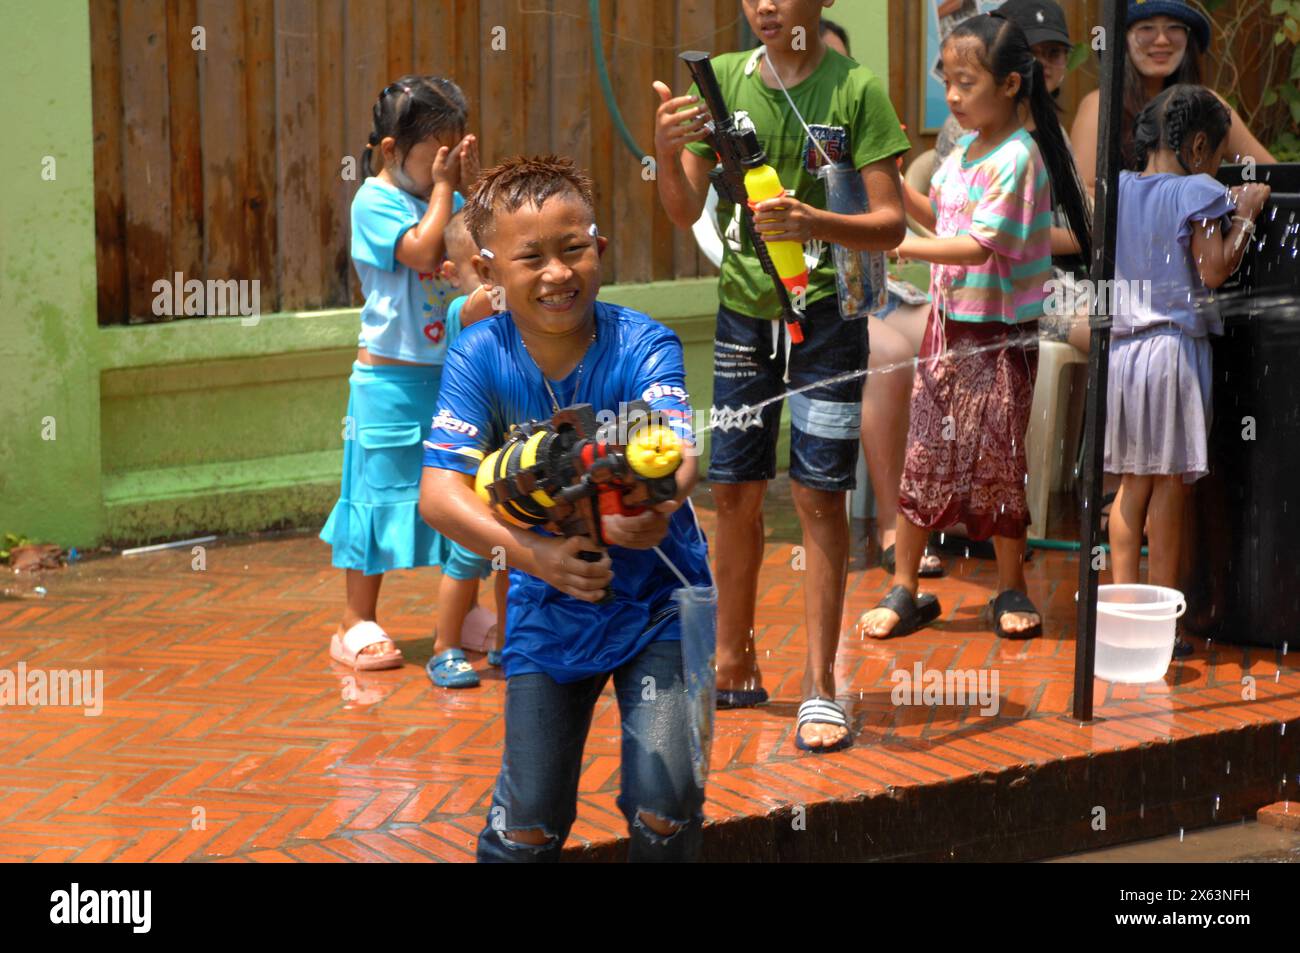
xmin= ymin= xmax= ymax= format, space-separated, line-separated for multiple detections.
xmin=1182 ymin=163 xmax=1300 ymax=647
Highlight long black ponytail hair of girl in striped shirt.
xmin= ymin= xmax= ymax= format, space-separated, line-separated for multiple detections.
xmin=944 ymin=10 xmax=1092 ymax=259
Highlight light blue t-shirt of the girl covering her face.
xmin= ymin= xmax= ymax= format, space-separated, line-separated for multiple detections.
xmin=352 ymin=177 xmax=465 ymax=364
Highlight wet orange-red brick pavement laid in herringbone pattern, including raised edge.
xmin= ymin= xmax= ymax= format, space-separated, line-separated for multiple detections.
xmin=0 ymin=494 xmax=1300 ymax=862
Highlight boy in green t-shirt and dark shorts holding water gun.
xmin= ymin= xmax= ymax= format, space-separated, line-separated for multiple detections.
xmin=654 ymin=0 xmax=911 ymax=751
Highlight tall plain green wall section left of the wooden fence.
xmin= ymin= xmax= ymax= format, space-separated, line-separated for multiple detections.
xmin=0 ymin=0 xmax=100 ymax=543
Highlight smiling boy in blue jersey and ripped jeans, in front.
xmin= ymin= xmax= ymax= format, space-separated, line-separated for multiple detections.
xmin=420 ymin=156 xmax=710 ymax=862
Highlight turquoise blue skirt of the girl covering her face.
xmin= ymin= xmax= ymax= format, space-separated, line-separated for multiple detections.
xmin=320 ymin=361 xmax=489 ymax=579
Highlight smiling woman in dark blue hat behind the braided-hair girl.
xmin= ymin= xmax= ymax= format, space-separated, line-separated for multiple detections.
xmin=1070 ymin=0 xmax=1277 ymax=192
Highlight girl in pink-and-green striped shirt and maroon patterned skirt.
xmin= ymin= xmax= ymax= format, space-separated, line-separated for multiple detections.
xmin=858 ymin=13 xmax=1089 ymax=638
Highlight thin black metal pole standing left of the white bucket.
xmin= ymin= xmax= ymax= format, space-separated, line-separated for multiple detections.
xmin=1074 ymin=0 xmax=1128 ymax=722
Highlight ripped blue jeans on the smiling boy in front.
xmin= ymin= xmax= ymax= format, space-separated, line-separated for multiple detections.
xmin=478 ymin=641 xmax=705 ymax=863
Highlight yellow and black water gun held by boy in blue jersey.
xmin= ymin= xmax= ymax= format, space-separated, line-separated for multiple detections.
xmin=475 ymin=400 xmax=683 ymax=602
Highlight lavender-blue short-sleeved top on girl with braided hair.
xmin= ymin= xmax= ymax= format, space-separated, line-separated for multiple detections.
xmin=1112 ymin=172 xmax=1235 ymax=338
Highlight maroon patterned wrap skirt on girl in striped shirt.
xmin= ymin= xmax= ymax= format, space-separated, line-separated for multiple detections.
xmin=898 ymin=308 xmax=1039 ymax=540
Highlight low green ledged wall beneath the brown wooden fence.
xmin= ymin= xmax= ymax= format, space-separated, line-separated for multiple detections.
xmin=99 ymin=280 xmax=733 ymax=545
